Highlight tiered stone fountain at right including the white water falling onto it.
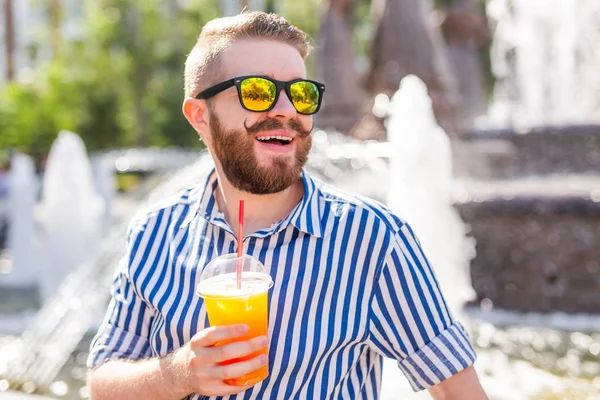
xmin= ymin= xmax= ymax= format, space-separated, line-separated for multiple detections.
xmin=453 ymin=0 xmax=600 ymax=316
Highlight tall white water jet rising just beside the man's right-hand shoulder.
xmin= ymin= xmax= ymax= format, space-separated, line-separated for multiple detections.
xmin=387 ymin=76 xmax=474 ymax=315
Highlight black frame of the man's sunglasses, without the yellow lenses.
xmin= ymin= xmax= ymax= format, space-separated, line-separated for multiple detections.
xmin=196 ymin=75 xmax=325 ymax=115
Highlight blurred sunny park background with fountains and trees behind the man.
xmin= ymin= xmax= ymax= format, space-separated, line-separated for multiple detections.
xmin=0 ymin=0 xmax=600 ymax=400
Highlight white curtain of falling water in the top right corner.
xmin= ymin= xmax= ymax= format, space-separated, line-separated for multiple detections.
xmin=487 ymin=0 xmax=600 ymax=127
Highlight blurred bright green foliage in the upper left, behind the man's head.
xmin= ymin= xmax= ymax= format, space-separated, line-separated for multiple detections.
xmin=0 ymin=0 xmax=219 ymax=154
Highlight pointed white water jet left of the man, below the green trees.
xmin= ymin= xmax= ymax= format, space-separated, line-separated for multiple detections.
xmin=40 ymin=131 xmax=104 ymax=299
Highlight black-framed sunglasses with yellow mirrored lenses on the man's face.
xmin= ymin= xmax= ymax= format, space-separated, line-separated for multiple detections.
xmin=196 ymin=75 xmax=325 ymax=115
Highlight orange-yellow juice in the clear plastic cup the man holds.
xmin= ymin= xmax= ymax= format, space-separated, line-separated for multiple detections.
xmin=198 ymin=272 xmax=272 ymax=386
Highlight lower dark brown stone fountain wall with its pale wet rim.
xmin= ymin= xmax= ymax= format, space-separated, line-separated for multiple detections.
xmin=458 ymin=179 xmax=600 ymax=313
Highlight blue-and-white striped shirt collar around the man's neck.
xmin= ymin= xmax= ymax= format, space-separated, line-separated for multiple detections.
xmin=197 ymin=168 xmax=323 ymax=238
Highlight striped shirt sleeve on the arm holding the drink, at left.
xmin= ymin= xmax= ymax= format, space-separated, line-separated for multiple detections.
xmin=87 ymin=216 xmax=154 ymax=368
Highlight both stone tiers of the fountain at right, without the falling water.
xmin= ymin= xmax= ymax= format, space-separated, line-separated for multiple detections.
xmin=454 ymin=126 xmax=600 ymax=313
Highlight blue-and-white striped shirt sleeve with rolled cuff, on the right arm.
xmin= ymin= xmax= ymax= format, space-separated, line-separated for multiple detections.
xmin=369 ymin=224 xmax=476 ymax=391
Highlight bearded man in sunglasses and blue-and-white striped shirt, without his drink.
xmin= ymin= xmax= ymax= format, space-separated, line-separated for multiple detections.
xmin=88 ymin=13 xmax=486 ymax=400
